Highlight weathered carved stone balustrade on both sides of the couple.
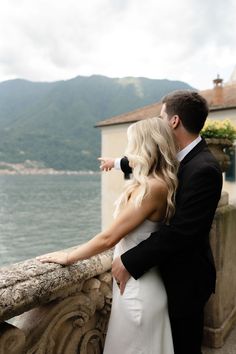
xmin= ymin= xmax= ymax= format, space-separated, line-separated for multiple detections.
xmin=0 ymin=193 xmax=236 ymax=354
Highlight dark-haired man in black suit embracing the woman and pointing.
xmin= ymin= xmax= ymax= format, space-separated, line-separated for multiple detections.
xmin=101 ymin=91 xmax=222 ymax=354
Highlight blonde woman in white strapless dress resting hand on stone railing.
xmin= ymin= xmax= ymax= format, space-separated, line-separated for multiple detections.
xmin=37 ymin=118 xmax=178 ymax=354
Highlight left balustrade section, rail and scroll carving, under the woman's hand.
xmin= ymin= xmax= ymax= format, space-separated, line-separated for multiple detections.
xmin=0 ymin=251 xmax=112 ymax=354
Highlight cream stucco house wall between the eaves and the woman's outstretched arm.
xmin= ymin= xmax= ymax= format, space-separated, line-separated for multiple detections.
xmin=101 ymin=124 xmax=129 ymax=229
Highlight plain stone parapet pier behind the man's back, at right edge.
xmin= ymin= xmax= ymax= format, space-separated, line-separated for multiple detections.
xmin=204 ymin=192 xmax=236 ymax=348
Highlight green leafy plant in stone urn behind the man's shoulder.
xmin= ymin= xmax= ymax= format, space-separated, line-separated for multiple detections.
xmin=201 ymin=119 xmax=236 ymax=172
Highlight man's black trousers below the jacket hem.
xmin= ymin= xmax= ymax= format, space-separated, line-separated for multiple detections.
xmin=170 ymin=310 xmax=204 ymax=354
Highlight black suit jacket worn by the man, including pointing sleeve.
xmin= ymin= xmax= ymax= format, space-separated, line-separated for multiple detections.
xmin=121 ymin=140 xmax=222 ymax=318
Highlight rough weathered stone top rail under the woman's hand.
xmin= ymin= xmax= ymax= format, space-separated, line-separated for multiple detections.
xmin=0 ymin=250 xmax=112 ymax=322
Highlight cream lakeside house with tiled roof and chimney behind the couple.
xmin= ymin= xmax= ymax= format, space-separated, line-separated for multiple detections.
xmin=97 ymin=76 xmax=236 ymax=228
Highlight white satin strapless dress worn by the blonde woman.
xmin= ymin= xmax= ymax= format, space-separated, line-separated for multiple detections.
xmin=103 ymin=220 xmax=174 ymax=354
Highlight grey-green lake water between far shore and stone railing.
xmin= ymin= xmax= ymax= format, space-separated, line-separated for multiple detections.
xmin=0 ymin=174 xmax=101 ymax=266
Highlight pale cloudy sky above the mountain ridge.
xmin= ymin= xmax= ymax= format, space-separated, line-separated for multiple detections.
xmin=0 ymin=0 xmax=236 ymax=90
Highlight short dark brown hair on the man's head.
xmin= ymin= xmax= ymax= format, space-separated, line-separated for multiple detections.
xmin=162 ymin=90 xmax=209 ymax=134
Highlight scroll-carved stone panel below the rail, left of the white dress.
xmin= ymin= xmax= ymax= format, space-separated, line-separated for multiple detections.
xmin=12 ymin=273 xmax=112 ymax=354
